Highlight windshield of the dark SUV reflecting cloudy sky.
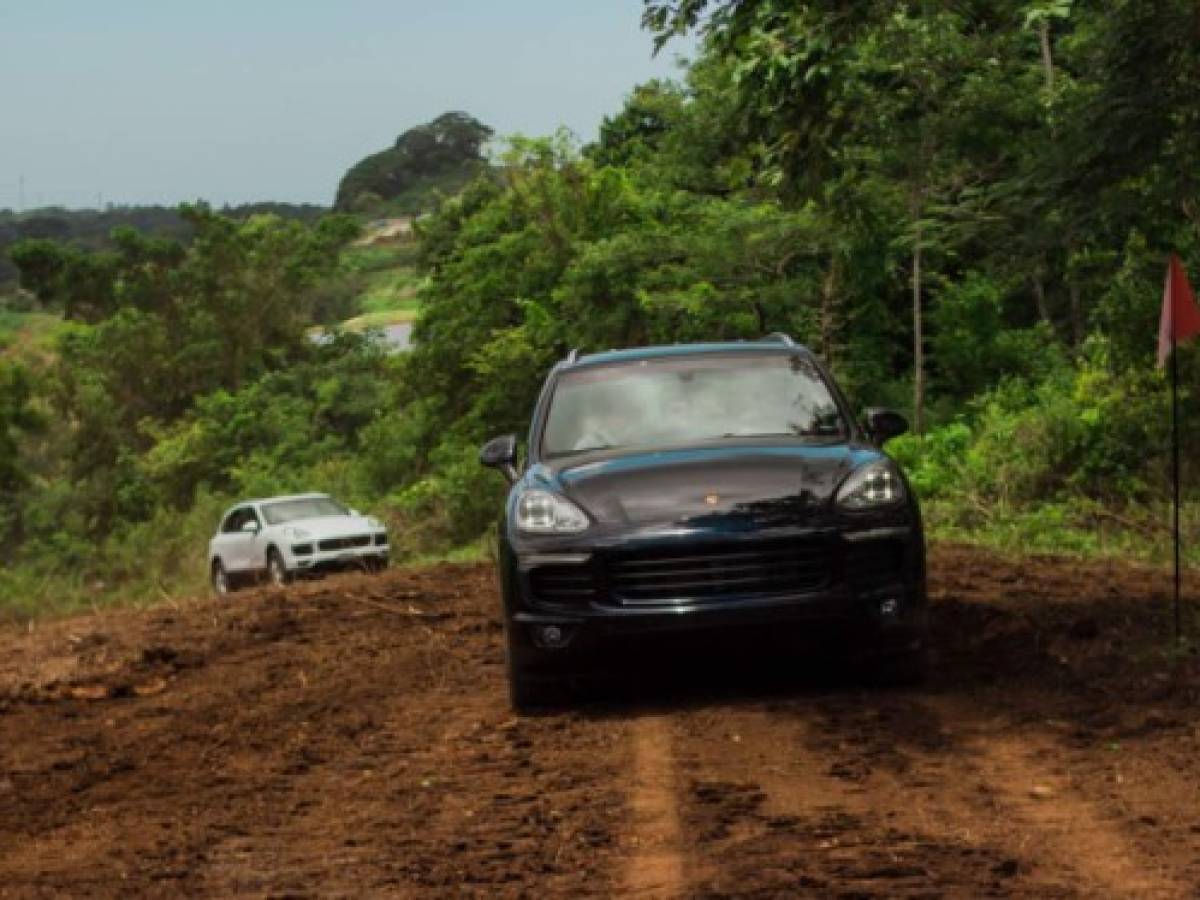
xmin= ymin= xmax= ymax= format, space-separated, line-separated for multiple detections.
xmin=541 ymin=353 xmax=844 ymax=457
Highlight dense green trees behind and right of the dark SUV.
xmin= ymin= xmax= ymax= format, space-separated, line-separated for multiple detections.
xmin=397 ymin=0 xmax=1200 ymax=547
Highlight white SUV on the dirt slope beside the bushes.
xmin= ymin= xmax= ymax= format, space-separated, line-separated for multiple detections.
xmin=209 ymin=493 xmax=388 ymax=594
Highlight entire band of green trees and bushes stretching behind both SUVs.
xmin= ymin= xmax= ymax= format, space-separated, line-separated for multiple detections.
xmin=0 ymin=0 xmax=1200 ymax=614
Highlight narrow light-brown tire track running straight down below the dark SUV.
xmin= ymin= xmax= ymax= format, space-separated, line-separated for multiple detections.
xmin=624 ymin=715 xmax=685 ymax=899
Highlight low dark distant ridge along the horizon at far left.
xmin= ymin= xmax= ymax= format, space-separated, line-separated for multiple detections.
xmin=0 ymin=203 xmax=329 ymax=294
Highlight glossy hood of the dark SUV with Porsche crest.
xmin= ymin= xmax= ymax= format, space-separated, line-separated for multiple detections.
xmin=527 ymin=443 xmax=881 ymax=526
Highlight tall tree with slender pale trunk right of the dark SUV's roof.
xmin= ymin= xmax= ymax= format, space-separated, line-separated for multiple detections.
xmin=643 ymin=0 xmax=1060 ymax=432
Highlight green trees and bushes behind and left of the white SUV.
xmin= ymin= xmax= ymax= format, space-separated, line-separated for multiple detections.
xmin=0 ymin=206 xmax=408 ymax=614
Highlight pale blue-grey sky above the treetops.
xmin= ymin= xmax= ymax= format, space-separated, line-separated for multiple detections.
xmin=0 ymin=0 xmax=694 ymax=209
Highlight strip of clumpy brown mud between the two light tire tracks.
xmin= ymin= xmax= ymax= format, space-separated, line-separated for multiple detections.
xmin=679 ymin=698 xmax=1032 ymax=898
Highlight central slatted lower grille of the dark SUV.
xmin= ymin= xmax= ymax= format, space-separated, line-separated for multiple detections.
xmin=608 ymin=540 xmax=834 ymax=606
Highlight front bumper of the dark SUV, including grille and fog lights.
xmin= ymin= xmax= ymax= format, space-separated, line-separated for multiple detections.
xmin=502 ymin=526 xmax=926 ymax=671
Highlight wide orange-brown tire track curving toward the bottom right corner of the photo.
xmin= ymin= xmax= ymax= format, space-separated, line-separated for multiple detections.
xmin=801 ymin=692 xmax=1190 ymax=898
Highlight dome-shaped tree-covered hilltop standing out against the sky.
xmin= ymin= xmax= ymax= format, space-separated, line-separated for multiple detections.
xmin=334 ymin=113 xmax=492 ymax=216
